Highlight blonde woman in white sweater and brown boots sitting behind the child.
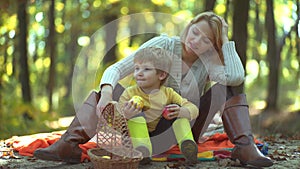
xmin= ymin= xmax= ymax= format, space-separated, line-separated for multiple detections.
xmin=34 ymin=12 xmax=273 ymax=167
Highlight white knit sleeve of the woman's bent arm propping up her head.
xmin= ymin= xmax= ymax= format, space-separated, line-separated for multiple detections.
xmin=201 ymin=41 xmax=245 ymax=86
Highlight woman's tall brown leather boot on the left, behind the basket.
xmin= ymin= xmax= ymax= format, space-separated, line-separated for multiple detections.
xmin=33 ymin=92 xmax=99 ymax=164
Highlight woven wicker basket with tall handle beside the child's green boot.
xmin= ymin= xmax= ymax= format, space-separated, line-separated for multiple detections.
xmin=88 ymin=102 xmax=142 ymax=169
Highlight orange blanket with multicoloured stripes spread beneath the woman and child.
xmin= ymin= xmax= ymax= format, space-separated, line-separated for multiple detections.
xmin=5 ymin=131 xmax=266 ymax=162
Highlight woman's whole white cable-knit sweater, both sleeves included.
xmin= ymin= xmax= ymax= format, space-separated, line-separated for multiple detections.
xmin=100 ymin=35 xmax=245 ymax=105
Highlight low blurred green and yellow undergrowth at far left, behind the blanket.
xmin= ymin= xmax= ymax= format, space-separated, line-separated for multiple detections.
xmin=0 ymin=78 xmax=54 ymax=138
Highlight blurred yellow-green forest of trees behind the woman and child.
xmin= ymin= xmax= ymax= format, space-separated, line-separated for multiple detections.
xmin=0 ymin=0 xmax=300 ymax=138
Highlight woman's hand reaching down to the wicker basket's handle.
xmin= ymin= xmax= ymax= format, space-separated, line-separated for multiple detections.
xmin=96 ymin=85 xmax=112 ymax=117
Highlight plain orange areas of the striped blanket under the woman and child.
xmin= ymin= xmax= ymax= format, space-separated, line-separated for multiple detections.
xmin=5 ymin=131 xmax=261 ymax=162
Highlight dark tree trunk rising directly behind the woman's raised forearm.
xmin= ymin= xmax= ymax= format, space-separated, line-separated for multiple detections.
xmin=232 ymin=0 xmax=249 ymax=91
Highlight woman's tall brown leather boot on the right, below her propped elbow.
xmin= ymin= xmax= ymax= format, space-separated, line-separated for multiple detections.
xmin=222 ymin=94 xmax=273 ymax=167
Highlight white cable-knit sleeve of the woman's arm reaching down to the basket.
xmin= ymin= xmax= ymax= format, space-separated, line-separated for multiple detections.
xmin=100 ymin=35 xmax=168 ymax=88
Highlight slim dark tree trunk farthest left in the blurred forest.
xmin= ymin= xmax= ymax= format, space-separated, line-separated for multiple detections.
xmin=18 ymin=0 xmax=31 ymax=103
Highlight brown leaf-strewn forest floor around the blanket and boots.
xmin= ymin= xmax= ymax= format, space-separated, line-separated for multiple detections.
xmin=0 ymin=109 xmax=300 ymax=169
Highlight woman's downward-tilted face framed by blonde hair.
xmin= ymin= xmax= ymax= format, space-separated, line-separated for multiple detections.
xmin=185 ymin=20 xmax=214 ymax=56
